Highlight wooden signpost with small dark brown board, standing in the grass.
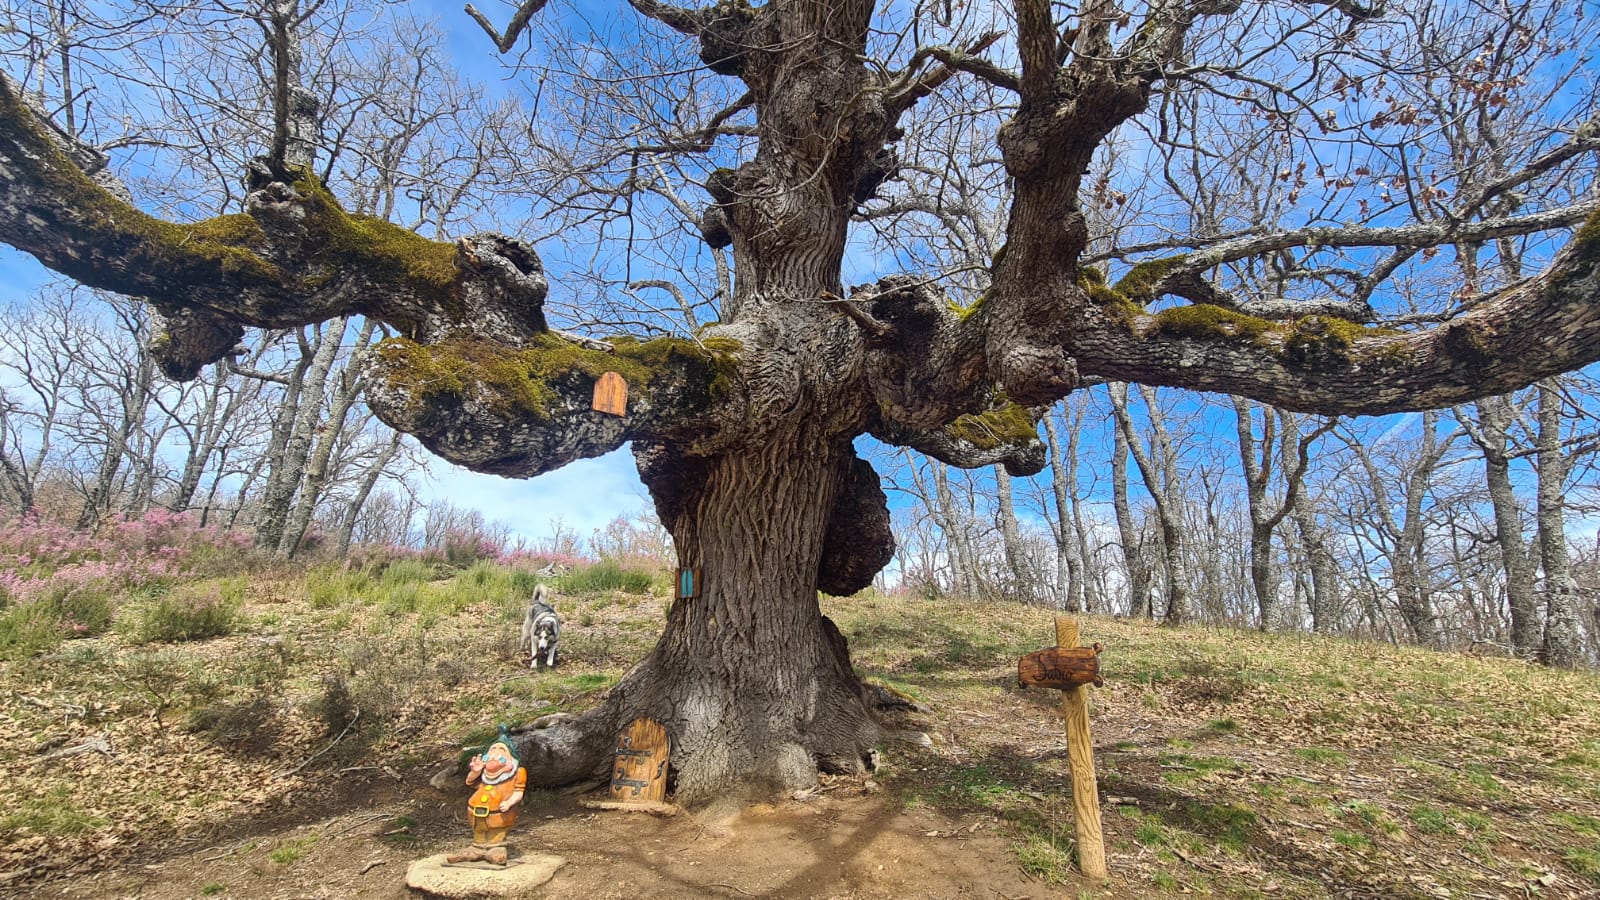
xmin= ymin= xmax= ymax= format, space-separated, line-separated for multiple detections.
xmin=1016 ymin=615 xmax=1107 ymax=878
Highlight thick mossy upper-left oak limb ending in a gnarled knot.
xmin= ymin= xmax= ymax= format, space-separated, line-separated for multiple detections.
xmin=0 ymin=75 xmax=547 ymax=378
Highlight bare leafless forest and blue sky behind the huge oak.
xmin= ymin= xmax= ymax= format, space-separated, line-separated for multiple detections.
xmin=0 ymin=0 xmax=1600 ymax=665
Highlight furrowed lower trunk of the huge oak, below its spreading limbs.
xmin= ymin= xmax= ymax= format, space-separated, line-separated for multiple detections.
xmin=522 ymin=436 xmax=882 ymax=804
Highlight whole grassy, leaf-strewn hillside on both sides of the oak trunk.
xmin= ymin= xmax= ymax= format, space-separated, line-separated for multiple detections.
xmin=0 ymin=559 xmax=1600 ymax=897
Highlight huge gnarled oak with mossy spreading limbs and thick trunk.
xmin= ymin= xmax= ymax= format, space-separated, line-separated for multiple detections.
xmin=0 ymin=0 xmax=1600 ymax=801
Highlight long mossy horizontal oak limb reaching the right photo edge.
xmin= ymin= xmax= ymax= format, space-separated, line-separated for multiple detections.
xmin=1062 ymin=213 xmax=1600 ymax=415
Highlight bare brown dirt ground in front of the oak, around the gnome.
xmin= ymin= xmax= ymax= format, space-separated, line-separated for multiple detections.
xmin=30 ymin=780 xmax=1070 ymax=900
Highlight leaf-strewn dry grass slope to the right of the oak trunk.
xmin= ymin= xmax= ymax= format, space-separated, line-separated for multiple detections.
xmin=832 ymin=597 xmax=1600 ymax=897
